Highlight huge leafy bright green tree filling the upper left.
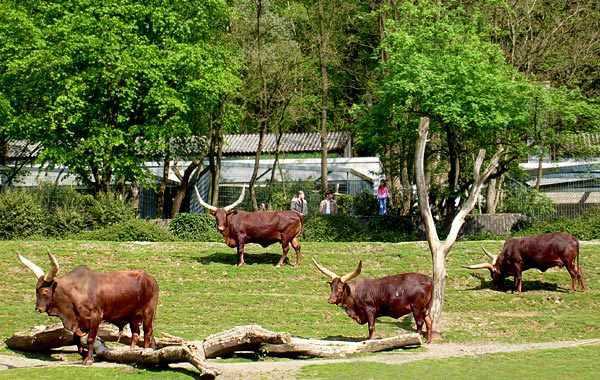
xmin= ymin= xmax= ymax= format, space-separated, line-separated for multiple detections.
xmin=7 ymin=0 xmax=240 ymax=193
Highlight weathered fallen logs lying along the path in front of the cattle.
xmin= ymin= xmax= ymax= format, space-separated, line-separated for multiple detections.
xmin=5 ymin=323 xmax=421 ymax=379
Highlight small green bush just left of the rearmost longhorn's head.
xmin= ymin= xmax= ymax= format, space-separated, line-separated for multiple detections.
xmin=169 ymin=213 xmax=223 ymax=241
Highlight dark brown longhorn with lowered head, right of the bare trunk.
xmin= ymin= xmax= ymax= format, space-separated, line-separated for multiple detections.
xmin=463 ymin=232 xmax=585 ymax=292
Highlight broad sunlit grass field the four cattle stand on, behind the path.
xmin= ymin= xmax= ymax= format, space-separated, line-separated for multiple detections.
xmin=0 ymin=241 xmax=600 ymax=378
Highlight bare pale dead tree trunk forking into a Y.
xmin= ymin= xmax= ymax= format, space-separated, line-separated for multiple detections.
xmin=415 ymin=117 xmax=502 ymax=331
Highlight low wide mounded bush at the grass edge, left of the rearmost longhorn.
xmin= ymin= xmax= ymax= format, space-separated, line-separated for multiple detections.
xmin=75 ymin=219 xmax=177 ymax=242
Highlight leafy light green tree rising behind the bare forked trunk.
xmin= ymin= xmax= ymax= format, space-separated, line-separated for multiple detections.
xmin=354 ymin=1 xmax=531 ymax=224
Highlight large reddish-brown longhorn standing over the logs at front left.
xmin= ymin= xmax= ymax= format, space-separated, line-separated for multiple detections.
xmin=17 ymin=252 xmax=158 ymax=365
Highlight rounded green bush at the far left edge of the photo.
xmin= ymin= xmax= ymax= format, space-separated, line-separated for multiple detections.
xmin=0 ymin=190 xmax=46 ymax=240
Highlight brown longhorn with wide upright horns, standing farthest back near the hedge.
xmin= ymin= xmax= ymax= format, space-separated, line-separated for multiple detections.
xmin=194 ymin=187 xmax=304 ymax=267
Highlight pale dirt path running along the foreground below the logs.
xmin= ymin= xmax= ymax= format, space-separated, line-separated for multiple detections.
xmin=0 ymin=339 xmax=600 ymax=380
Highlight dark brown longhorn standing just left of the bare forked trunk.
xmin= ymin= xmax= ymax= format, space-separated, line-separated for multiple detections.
xmin=313 ymin=259 xmax=433 ymax=343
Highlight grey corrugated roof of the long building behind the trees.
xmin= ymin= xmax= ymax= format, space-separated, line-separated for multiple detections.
xmin=223 ymin=132 xmax=351 ymax=157
